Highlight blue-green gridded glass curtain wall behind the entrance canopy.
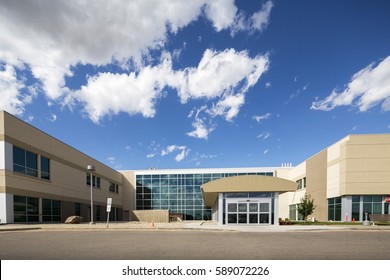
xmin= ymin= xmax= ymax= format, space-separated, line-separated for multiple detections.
xmin=136 ymin=172 xmax=273 ymax=220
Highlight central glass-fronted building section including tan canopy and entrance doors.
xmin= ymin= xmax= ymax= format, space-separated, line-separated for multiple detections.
xmin=128 ymin=167 xmax=296 ymax=225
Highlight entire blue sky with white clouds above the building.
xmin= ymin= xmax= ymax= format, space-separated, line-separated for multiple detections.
xmin=0 ymin=0 xmax=390 ymax=169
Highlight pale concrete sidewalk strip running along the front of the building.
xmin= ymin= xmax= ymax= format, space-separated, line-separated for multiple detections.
xmin=0 ymin=221 xmax=390 ymax=232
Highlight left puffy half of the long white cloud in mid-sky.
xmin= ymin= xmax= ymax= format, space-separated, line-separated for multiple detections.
xmin=72 ymin=59 xmax=174 ymax=123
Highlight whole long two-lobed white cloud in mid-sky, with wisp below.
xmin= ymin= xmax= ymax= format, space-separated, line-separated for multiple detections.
xmin=72 ymin=49 xmax=269 ymax=129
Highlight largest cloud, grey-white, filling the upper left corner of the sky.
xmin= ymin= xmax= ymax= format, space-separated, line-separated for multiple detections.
xmin=0 ymin=0 xmax=269 ymax=104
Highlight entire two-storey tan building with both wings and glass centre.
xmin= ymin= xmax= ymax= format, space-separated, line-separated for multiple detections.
xmin=0 ymin=111 xmax=390 ymax=225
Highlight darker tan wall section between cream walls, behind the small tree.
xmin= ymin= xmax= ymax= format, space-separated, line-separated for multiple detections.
xmin=306 ymin=150 xmax=328 ymax=221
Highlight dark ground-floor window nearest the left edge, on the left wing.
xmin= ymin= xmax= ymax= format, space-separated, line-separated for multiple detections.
xmin=14 ymin=195 xmax=39 ymax=223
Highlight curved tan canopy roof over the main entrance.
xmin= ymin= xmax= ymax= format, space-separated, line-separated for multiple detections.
xmin=201 ymin=175 xmax=297 ymax=207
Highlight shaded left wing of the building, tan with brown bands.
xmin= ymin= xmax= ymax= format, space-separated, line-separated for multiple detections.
xmin=0 ymin=111 xmax=134 ymax=223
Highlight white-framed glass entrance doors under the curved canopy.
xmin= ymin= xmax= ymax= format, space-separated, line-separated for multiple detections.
xmin=226 ymin=199 xmax=271 ymax=225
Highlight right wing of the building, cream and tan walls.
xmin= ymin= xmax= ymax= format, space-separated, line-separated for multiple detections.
xmin=280 ymin=134 xmax=390 ymax=221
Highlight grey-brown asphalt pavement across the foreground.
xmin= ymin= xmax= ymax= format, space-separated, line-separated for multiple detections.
xmin=0 ymin=226 xmax=390 ymax=260
